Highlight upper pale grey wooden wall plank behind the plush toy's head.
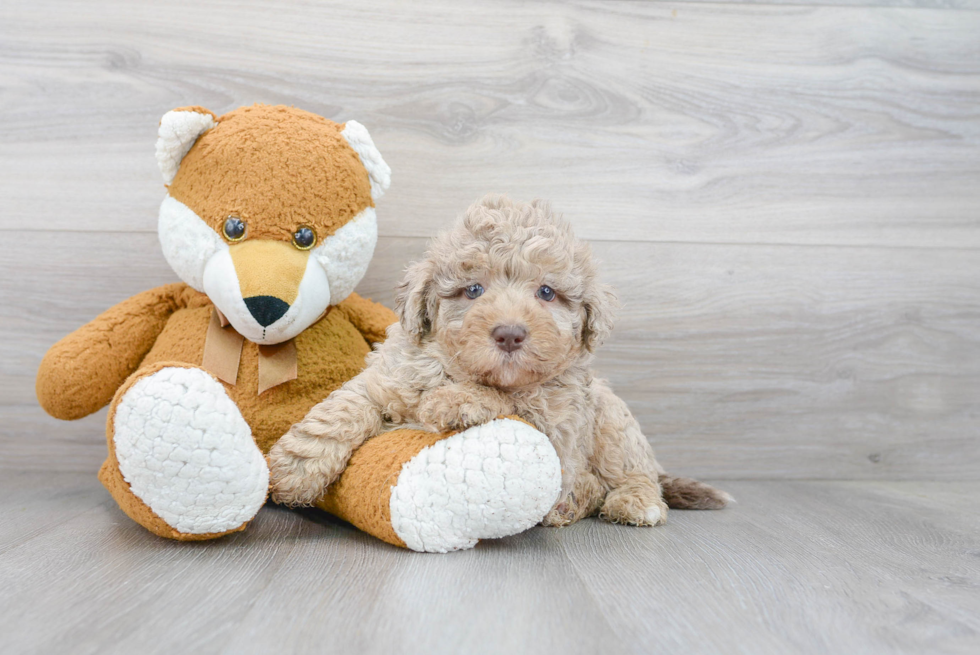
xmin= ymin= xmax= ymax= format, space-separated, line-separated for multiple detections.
xmin=0 ymin=0 xmax=980 ymax=248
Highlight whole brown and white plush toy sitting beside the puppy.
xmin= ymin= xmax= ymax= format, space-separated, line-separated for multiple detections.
xmin=37 ymin=105 xmax=560 ymax=552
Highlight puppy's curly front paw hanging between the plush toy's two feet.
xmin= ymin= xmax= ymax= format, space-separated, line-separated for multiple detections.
xmin=267 ymin=433 xmax=350 ymax=507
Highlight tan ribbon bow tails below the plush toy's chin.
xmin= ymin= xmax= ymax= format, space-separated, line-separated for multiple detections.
xmin=201 ymin=307 xmax=299 ymax=395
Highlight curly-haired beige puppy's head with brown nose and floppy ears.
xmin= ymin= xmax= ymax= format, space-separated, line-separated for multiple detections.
xmin=396 ymin=196 xmax=615 ymax=389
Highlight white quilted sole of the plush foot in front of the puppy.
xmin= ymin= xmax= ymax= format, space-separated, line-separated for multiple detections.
xmin=390 ymin=419 xmax=561 ymax=553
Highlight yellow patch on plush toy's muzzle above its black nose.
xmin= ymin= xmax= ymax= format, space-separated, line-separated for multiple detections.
xmin=228 ymin=239 xmax=310 ymax=305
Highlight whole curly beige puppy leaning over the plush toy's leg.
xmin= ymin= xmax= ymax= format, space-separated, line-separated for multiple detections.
xmin=269 ymin=196 xmax=730 ymax=526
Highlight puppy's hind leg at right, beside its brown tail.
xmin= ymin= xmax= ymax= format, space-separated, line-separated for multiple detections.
xmin=592 ymin=381 xmax=667 ymax=525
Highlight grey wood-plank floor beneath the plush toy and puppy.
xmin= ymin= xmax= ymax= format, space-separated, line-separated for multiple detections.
xmin=0 ymin=473 xmax=980 ymax=655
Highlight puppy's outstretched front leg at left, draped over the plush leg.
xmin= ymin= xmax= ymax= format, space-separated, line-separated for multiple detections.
xmin=268 ymin=368 xmax=384 ymax=506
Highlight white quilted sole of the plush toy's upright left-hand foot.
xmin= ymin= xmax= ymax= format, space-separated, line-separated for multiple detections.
xmin=113 ymin=367 xmax=269 ymax=534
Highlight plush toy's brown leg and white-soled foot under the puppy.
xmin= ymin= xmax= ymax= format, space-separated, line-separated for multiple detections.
xmin=317 ymin=419 xmax=561 ymax=553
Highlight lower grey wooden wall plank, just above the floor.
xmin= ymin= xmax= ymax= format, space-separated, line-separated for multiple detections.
xmin=0 ymin=232 xmax=980 ymax=480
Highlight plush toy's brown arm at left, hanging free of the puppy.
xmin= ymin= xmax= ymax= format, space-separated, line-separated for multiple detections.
xmin=35 ymin=283 xmax=203 ymax=420
